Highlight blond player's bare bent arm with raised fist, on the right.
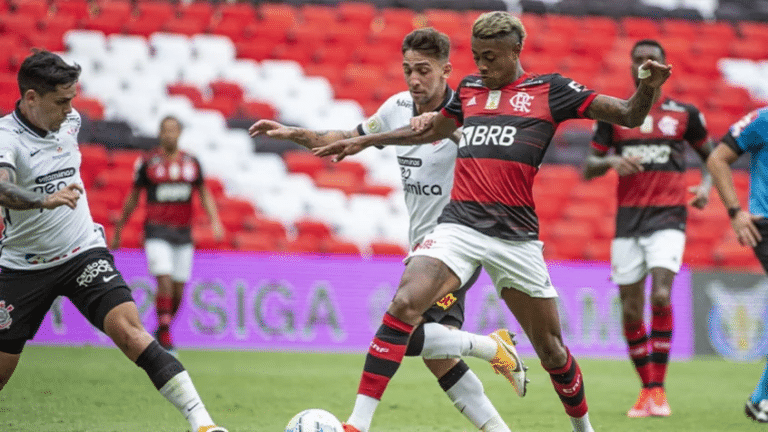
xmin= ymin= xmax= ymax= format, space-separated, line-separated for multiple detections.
xmin=584 ymin=60 xmax=672 ymax=127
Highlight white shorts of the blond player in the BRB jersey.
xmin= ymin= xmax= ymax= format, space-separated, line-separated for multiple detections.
xmin=406 ymin=223 xmax=557 ymax=298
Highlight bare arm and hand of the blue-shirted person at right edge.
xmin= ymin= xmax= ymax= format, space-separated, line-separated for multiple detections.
xmin=707 ymin=142 xmax=762 ymax=247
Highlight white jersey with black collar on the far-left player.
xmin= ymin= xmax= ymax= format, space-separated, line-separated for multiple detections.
xmin=0 ymin=108 xmax=106 ymax=270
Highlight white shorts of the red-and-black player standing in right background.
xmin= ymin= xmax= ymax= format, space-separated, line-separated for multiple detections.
xmin=611 ymin=229 xmax=685 ymax=285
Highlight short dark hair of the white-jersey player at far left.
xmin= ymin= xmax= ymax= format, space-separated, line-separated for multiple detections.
xmin=17 ymin=50 xmax=82 ymax=96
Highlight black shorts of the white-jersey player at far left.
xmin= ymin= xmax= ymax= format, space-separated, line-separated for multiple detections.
xmin=0 ymin=248 xmax=133 ymax=354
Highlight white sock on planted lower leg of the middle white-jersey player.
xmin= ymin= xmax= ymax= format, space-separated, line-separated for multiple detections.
xmin=445 ymin=370 xmax=510 ymax=432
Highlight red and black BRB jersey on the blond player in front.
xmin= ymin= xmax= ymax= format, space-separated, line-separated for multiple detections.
xmin=438 ymin=74 xmax=596 ymax=240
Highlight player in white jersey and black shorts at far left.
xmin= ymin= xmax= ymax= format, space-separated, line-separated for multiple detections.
xmin=0 ymin=51 xmax=226 ymax=432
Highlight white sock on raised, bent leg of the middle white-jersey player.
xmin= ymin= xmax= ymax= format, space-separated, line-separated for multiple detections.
xmin=421 ymin=323 xmax=498 ymax=361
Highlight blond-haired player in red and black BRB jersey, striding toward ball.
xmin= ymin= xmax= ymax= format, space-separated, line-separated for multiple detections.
xmin=314 ymin=12 xmax=670 ymax=432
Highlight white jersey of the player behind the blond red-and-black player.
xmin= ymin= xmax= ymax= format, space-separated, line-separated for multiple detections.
xmin=357 ymin=88 xmax=457 ymax=250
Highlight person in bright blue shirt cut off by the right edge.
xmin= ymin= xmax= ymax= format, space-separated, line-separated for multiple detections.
xmin=707 ymin=108 xmax=768 ymax=423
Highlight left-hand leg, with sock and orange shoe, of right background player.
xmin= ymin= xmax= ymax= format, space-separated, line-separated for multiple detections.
xmin=619 ymin=278 xmax=651 ymax=418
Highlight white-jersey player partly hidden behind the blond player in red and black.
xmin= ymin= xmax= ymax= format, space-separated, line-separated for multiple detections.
xmin=250 ymin=28 xmax=525 ymax=432
